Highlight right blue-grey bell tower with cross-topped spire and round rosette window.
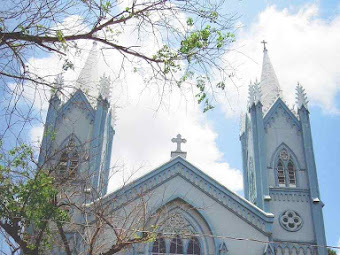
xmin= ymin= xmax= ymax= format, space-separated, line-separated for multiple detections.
xmin=240 ymin=42 xmax=327 ymax=255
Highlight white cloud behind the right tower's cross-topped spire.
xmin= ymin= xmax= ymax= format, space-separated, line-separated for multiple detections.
xmin=216 ymin=5 xmax=340 ymax=116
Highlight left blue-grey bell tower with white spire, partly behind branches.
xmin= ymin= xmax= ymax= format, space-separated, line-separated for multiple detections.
xmin=39 ymin=44 xmax=115 ymax=197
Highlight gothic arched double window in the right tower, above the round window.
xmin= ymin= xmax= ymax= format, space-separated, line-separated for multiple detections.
xmin=276 ymin=149 xmax=296 ymax=187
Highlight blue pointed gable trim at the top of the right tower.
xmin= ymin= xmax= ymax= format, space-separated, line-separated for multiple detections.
xmin=263 ymin=97 xmax=301 ymax=130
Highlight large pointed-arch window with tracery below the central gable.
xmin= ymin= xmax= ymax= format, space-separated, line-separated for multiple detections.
xmin=146 ymin=198 xmax=216 ymax=255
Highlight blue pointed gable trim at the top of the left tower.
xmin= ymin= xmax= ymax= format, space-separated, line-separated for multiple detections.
xmin=58 ymin=89 xmax=94 ymax=119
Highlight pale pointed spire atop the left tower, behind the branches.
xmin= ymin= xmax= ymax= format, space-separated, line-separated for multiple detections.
xmin=77 ymin=42 xmax=99 ymax=101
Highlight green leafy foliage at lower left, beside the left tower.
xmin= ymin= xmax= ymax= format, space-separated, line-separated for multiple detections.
xmin=0 ymin=141 xmax=68 ymax=254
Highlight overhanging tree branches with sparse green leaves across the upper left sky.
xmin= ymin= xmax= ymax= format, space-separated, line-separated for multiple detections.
xmin=0 ymin=0 xmax=234 ymax=111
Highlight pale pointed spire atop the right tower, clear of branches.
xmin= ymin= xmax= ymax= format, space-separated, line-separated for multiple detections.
xmin=261 ymin=41 xmax=281 ymax=110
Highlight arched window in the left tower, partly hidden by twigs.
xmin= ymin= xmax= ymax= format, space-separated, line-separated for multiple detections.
xmin=58 ymin=150 xmax=79 ymax=178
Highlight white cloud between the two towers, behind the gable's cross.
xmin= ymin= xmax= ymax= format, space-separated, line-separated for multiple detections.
xmin=105 ymin=51 xmax=242 ymax=191
